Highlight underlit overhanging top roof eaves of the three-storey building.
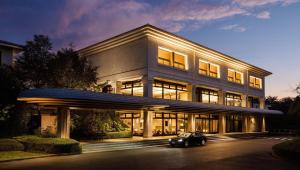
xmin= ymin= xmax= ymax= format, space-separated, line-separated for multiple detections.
xmin=79 ymin=24 xmax=272 ymax=76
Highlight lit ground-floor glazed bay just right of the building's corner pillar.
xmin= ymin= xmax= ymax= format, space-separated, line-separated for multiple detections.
xmin=152 ymin=113 xmax=187 ymax=136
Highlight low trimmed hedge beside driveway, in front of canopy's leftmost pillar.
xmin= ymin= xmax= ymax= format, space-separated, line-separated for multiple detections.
xmin=15 ymin=136 xmax=81 ymax=154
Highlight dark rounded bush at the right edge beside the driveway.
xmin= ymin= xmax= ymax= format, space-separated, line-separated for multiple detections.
xmin=272 ymin=138 xmax=300 ymax=160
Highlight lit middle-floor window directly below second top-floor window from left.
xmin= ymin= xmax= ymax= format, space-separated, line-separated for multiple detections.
xmin=196 ymin=87 xmax=219 ymax=104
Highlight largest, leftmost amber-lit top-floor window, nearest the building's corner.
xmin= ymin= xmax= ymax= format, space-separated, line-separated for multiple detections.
xmin=157 ymin=47 xmax=187 ymax=70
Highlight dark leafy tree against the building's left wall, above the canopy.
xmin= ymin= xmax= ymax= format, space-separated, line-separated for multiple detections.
xmin=48 ymin=47 xmax=97 ymax=89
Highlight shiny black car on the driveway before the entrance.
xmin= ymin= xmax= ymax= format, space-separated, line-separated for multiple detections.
xmin=169 ymin=132 xmax=207 ymax=147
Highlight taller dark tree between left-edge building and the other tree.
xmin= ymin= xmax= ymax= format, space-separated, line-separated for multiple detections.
xmin=15 ymin=35 xmax=53 ymax=88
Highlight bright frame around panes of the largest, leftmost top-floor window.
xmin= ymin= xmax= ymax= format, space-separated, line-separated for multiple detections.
xmin=157 ymin=46 xmax=188 ymax=70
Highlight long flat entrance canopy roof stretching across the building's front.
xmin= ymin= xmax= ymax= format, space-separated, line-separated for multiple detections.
xmin=18 ymin=88 xmax=282 ymax=114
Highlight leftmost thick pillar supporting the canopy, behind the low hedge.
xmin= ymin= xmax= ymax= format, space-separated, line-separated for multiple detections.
xmin=57 ymin=108 xmax=71 ymax=138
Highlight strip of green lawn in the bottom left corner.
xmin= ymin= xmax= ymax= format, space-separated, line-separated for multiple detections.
xmin=0 ymin=151 xmax=49 ymax=161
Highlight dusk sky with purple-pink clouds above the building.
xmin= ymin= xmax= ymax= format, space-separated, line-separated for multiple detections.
xmin=0 ymin=0 xmax=300 ymax=98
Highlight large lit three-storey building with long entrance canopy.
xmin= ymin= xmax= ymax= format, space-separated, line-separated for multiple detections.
xmin=19 ymin=25 xmax=281 ymax=137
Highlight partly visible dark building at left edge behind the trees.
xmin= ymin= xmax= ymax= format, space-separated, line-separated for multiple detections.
xmin=0 ymin=40 xmax=23 ymax=65
